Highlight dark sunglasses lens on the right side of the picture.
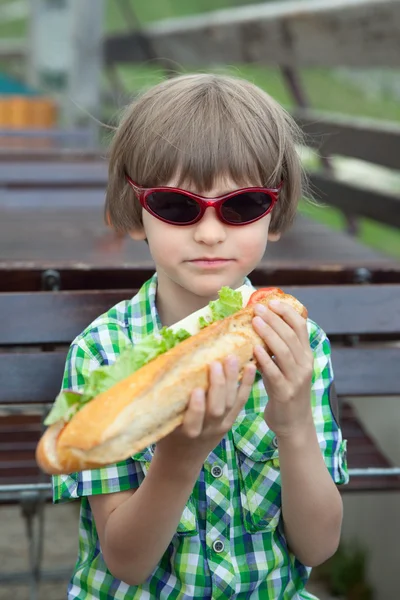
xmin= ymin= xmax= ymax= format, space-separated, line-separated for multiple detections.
xmin=221 ymin=192 xmax=272 ymax=224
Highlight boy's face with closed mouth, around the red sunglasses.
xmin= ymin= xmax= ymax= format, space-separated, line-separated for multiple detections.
xmin=131 ymin=178 xmax=280 ymax=299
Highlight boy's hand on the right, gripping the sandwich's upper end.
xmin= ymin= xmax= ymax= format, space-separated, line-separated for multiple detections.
xmin=253 ymin=301 xmax=314 ymax=438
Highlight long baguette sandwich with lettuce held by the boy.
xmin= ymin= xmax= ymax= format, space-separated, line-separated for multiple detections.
xmin=36 ymin=285 xmax=307 ymax=474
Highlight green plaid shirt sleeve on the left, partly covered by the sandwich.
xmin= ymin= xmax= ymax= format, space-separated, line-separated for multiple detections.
xmin=52 ymin=339 xmax=144 ymax=504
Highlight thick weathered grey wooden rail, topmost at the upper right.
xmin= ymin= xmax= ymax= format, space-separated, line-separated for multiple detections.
xmin=104 ymin=0 xmax=400 ymax=68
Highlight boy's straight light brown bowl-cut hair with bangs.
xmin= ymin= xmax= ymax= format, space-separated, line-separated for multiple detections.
xmin=105 ymin=74 xmax=306 ymax=233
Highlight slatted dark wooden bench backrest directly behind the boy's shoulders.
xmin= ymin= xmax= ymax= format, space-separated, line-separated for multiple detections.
xmin=0 ymin=284 xmax=400 ymax=403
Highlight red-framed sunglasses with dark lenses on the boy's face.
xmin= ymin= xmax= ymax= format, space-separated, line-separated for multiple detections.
xmin=125 ymin=174 xmax=283 ymax=230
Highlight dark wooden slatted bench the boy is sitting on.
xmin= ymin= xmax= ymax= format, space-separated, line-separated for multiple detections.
xmin=0 ymin=270 xmax=400 ymax=586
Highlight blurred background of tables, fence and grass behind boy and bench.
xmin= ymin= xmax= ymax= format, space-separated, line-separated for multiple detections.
xmin=0 ymin=0 xmax=400 ymax=600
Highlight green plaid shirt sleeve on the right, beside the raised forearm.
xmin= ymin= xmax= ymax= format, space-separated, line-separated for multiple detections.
xmin=310 ymin=322 xmax=349 ymax=484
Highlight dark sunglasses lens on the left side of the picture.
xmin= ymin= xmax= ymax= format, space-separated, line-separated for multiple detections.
xmin=146 ymin=191 xmax=200 ymax=223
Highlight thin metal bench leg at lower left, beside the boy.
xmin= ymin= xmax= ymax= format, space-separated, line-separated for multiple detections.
xmin=21 ymin=492 xmax=45 ymax=600
